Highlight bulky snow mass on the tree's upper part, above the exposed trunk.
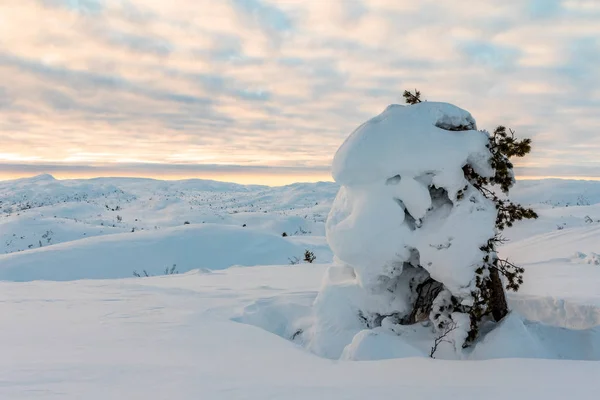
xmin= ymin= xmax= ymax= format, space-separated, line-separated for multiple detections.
xmin=326 ymin=102 xmax=495 ymax=294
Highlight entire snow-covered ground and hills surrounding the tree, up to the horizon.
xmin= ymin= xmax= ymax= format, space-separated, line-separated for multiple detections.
xmin=0 ymin=176 xmax=600 ymax=399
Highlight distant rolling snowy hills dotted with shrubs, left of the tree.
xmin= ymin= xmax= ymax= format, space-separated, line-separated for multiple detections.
xmin=0 ymin=175 xmax=338 ymax=256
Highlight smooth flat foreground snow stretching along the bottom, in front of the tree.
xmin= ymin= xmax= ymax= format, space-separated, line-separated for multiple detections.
xmin=0 ymin=266 xmax=600 ymax=400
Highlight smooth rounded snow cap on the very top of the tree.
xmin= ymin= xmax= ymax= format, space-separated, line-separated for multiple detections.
xmin=332 ymin=102 xmax=489 ymax=186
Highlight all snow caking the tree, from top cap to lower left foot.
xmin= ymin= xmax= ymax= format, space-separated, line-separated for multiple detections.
xmin=308 ymin=102 xmax=496 ymax=358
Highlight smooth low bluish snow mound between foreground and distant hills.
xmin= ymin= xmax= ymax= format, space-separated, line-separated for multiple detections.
xmin=0 ymin=224 xmax=330 ymax=281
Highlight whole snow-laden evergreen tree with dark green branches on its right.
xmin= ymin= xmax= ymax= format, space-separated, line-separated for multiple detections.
xmin=309 ymin=92 xmax=536 ymax=356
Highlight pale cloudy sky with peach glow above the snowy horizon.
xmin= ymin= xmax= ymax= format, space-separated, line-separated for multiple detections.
xmin=0 ymin=0 xmax=600 ymax=183
